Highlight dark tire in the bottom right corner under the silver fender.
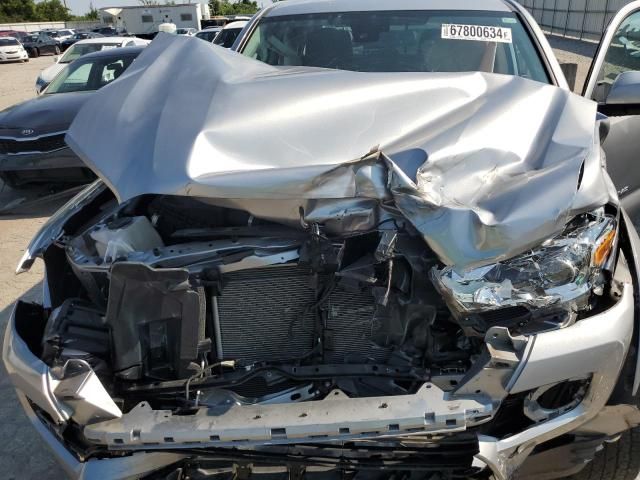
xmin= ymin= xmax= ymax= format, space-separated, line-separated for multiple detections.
xmin=568 ymin=427 xmax=640 ymax=480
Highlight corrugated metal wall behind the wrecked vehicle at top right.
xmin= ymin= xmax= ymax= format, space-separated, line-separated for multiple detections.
xmin=520 ymin=0 xmax=631 ymax=41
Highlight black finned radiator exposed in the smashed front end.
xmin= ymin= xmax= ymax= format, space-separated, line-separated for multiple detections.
xmin=217 ymin=265 xmax=390 ymax=363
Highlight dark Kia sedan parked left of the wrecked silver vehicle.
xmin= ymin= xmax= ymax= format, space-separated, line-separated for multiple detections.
xmin=0 ymin=47 xmax=142 ymax=188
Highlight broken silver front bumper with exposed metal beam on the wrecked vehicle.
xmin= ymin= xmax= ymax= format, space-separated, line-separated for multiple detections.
xmin=3 ymin=266 xmax=634 ymax=479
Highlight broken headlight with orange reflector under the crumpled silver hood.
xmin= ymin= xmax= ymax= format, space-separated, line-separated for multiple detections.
xmin=432 ymin=208 xmax=617 ymax=315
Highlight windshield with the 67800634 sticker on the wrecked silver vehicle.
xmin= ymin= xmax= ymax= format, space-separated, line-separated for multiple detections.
xmin=242 ymin=10 xmax=549 ymax=83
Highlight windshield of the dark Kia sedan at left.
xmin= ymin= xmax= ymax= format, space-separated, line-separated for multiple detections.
xmin=44 ymin=55 xmax=135 ymax=94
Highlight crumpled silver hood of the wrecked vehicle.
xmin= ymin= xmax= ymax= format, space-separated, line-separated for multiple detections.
xmin=67 ymin=35 xmax=615 ymax=268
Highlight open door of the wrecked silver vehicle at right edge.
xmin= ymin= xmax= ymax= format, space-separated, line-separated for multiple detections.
xmin=583 ymin=0 xmax=640 ymax=228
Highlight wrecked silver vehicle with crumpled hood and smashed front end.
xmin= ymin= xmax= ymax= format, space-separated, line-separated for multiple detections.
xmin=11 ymin=0 xmax=640 ymax=480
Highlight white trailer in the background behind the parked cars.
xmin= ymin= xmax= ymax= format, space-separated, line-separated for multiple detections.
xmin=101 ymin=2 xmax=210 ymax=36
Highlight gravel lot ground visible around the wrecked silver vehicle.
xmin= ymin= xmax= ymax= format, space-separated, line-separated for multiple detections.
xmin=0 ymin=37 xmax=596 ymax=479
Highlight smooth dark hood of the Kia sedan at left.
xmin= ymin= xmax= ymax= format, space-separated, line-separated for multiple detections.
xmin=0 ymin=92 xmax=92 ymax=136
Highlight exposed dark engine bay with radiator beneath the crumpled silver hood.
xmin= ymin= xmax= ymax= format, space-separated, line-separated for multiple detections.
xmin=43 ymin=192 xmax=484 ymax=411
